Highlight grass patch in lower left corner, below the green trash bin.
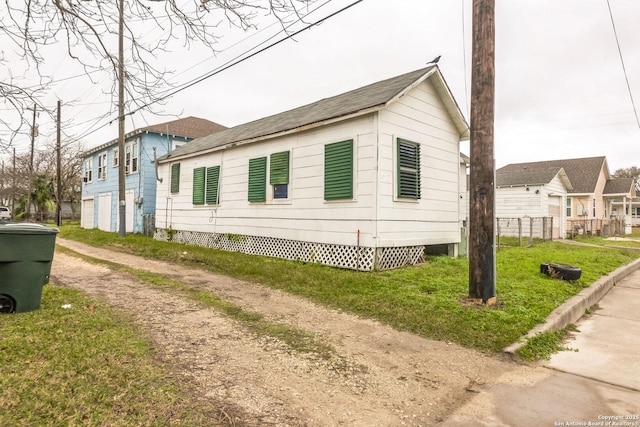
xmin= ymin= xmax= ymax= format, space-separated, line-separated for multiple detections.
xmin=0 ymin=285 xmax=219 ymax=426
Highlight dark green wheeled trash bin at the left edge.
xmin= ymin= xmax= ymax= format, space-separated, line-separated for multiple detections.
xmin=0 ymin=222 xmax=58 ymax=313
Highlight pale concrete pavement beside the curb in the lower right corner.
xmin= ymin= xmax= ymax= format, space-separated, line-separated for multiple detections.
xmin=443 ymin=270 xmax=640 ymax=426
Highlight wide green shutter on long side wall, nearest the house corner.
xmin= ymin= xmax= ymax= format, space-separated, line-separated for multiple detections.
xmin=324 ymin=139 xmax=353 ymax=200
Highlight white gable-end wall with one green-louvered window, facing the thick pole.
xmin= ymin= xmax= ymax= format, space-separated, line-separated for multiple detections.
xmin=378 ymin=80 xmax=461 ymax=246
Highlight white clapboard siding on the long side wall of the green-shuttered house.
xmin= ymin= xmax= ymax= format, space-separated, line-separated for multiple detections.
xmin=156 ymin=114 xmax=375 ymax=245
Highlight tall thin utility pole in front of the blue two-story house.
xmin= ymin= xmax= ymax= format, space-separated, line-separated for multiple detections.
xmin=118 ymin=0 xmax=127 ymax=237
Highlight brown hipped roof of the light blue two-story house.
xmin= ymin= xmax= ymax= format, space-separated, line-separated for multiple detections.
xmin=82 ymin=116 xmax=227 ymax=157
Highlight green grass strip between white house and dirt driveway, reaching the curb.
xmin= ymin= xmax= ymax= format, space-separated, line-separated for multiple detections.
xmin=61 ymin=226 xmax=640 ymax=353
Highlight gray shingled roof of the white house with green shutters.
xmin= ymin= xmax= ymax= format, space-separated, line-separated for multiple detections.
xmin=158 ymin=66 xmax=468 ymax=161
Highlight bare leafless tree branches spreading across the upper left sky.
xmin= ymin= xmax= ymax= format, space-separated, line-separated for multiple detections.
xmin=0 ymin=0 xmax=310 ymax=139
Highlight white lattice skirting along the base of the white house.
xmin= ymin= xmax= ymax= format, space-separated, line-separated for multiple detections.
xmin=153 ymin=228 xmax=425 ymax=271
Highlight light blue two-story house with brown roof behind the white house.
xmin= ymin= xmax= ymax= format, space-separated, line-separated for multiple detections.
xmin=80 ymin=117 xmax=226 ymax=233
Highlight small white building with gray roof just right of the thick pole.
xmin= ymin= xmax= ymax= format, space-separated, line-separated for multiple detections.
xmin=496 ymin=164 xmax=573 ymax=239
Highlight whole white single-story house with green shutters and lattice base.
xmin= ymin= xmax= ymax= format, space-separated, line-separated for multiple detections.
xmin=156 ymin=66 xmax=469 ymax=270
